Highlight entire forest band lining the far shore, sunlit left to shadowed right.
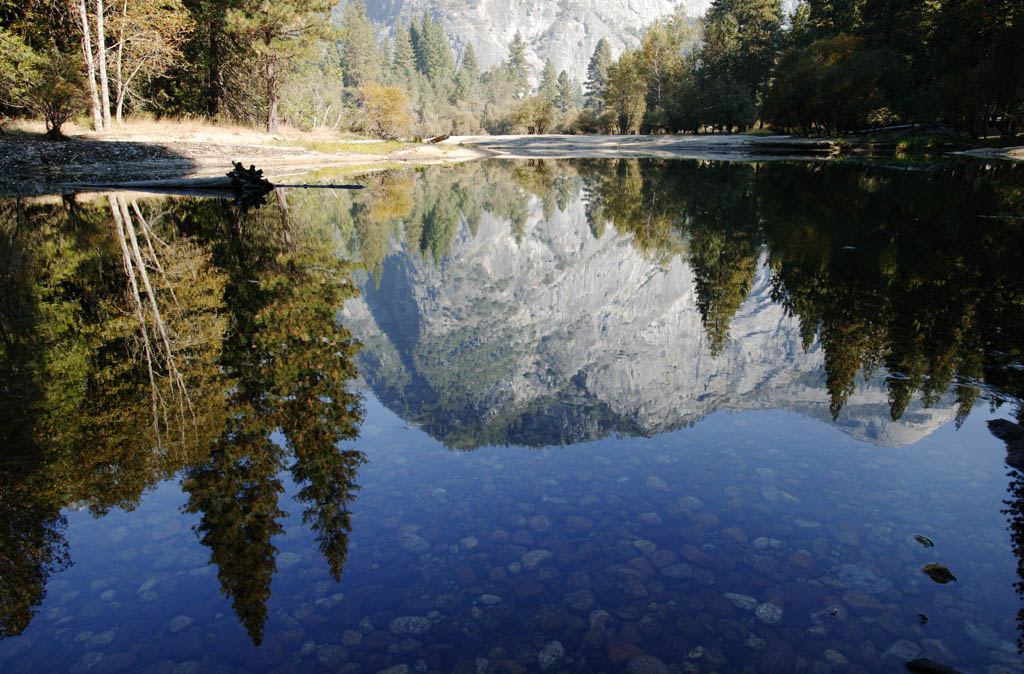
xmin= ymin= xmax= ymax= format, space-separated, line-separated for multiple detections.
xmin=0 ymin=0 xmax=1024 ymax=137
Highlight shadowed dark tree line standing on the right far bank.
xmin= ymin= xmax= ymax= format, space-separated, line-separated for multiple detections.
xmin=581 ymin=0 xmax=1024 ymax=136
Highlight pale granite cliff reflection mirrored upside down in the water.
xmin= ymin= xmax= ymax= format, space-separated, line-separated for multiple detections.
xmin=345 ymin=191 xmax=954 ymax=448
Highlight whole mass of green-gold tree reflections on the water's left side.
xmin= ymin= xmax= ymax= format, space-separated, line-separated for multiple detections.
xmin=0 ymin=195 xmax=364 ymax=643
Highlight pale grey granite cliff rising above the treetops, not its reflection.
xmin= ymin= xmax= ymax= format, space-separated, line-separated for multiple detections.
xmin=367 ymin=0 xmax=711 ymax=83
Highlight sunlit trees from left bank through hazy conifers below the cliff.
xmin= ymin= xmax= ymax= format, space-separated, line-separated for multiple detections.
xmin=0 ymin=0 xmax=582 ymax=137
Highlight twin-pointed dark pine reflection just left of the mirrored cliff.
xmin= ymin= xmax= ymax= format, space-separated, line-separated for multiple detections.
xmin=185 ymin=192 xmax=364 ymax=643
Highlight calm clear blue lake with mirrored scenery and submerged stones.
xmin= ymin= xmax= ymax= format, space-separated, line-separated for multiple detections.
xmin=0 ymin=154 xmax=1024 ymax=674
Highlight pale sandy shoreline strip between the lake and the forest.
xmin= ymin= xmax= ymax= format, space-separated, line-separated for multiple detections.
xmin=0 ymin=129 xmax=1024 ymax=197
